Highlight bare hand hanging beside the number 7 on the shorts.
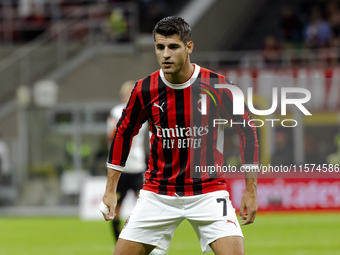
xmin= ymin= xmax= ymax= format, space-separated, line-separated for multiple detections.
xmin=240 ymin=189 xmax=258 ymax=225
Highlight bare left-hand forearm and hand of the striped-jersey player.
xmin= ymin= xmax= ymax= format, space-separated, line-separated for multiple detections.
xmin=101 ymin=168 xmax=122 ymax=221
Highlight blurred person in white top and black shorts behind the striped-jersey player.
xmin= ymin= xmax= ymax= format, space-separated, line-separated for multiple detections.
xmin=107 ymin=81 xmax=147 ymax=243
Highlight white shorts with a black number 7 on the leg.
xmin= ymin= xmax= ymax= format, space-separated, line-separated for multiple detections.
xmin=119 ymin=190 xmax=243 ymax=253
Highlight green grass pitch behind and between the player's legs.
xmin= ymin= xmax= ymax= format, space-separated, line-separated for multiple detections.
xmin=0 ymin=213 xmax=340 ymax=255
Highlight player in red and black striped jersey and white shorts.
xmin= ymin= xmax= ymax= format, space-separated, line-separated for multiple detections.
xmin=100 ymin=17 xmax=258 ymax=255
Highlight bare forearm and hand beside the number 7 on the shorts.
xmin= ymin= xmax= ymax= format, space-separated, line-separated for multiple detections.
xmin=240 ymin=169 xmax=258 ymax=225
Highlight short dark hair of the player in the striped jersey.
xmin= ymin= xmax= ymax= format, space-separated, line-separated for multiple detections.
xmin=152 ymin=16 xmax=191 ymax=43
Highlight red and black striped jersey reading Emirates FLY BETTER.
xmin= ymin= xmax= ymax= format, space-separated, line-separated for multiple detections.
xmin=107 ymin=65 xmax=259 ymax=196
